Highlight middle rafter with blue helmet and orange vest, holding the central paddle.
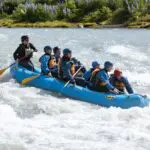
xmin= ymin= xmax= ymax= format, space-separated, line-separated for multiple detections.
xmin=59 ymin=48 xmax=86 ymax=87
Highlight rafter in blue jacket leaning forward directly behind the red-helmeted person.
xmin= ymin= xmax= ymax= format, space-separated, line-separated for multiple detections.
xmin=91 ymin=61 xmax=119 ymax=94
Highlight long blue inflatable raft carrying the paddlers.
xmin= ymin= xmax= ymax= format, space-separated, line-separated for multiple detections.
xmin=10 ymin=66 xmax=150 ymax=108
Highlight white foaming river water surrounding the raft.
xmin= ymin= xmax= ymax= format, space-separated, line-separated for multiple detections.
xmin=0 ymin=28 xmax=150 ymax=150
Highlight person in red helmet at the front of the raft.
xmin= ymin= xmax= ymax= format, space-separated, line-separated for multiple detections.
xmin=110 ymin=69 xmax=133 ymax=94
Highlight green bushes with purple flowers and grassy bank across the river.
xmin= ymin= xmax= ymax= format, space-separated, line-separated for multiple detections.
xmin=0 ymin=0 xmax=150 ymax=27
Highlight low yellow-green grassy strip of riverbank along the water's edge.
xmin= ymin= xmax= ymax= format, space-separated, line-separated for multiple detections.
xmin=0 ymin=19 xmax=150 ymax=28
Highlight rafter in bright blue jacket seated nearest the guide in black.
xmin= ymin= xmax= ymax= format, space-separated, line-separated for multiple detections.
xmin=39 ymin=46 xmax=58 ymax=77
